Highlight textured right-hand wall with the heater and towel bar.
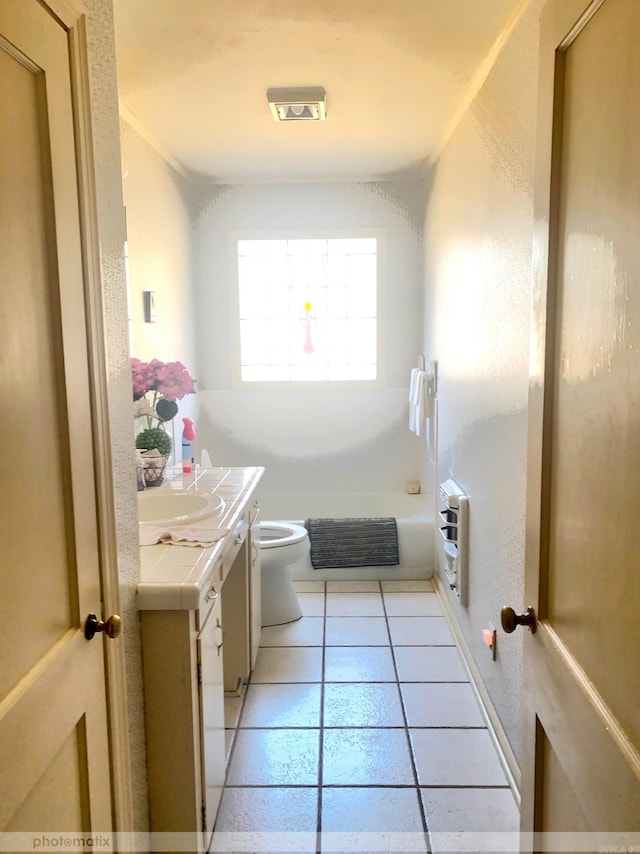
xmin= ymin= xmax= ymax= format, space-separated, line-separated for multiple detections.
xmin=425 ymin=0 xmax=541 ymax=756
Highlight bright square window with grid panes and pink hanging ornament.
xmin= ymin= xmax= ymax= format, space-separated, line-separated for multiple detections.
xmin=231 ymin=229 xmax=384 ymax=384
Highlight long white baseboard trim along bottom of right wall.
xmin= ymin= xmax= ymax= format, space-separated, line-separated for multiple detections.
xmin=431 ymin=572 xmax=521 ymax=808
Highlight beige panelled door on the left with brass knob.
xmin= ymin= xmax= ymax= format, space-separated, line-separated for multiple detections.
xmin=0 ymin=0 xmax=118 ymax=850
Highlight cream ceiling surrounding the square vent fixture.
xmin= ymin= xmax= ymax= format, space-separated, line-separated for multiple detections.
xmin=114 ymin=0 xmax=522 ymax=183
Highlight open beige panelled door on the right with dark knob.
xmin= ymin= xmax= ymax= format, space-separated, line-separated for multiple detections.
xmin=520 ymin=0 xmax=640 ymax=851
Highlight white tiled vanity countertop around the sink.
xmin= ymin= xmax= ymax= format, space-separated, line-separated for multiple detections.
xmin=137 ymin=466 xmax=264 ymax=611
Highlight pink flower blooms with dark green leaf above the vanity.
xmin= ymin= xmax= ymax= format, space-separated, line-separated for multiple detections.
xmin=131 ymin=357 xmax=195 ymax=426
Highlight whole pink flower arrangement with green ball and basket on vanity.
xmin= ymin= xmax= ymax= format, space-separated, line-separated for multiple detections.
xmin=131 ymin=357 xmax=195 ymax=486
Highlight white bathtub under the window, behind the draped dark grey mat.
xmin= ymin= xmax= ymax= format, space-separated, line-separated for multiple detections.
xmin=260 ymin=492 xmax=434 ymax=581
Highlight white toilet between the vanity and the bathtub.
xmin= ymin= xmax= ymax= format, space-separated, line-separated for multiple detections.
xmin=256 ymin=522 xmax=309 ymax=626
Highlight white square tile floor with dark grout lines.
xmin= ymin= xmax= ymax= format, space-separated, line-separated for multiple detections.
xmin=211 ymin=581 xmax=519 ymax=854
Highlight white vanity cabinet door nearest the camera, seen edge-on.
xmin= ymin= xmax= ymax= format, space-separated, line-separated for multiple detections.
xmin=197 ymin=591 xmax=226 ymax=850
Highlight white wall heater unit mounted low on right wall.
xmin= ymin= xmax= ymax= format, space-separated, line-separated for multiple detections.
xmin=439 ymin=480 xmax=469 ymax=607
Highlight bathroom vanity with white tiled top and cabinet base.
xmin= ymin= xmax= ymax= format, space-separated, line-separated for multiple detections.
xmin=137 ymin=467 xmax=264 ymax=852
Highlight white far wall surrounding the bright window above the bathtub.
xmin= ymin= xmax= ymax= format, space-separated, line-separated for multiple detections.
xmin=194 ymin=182 xmax=425 ymax=492
